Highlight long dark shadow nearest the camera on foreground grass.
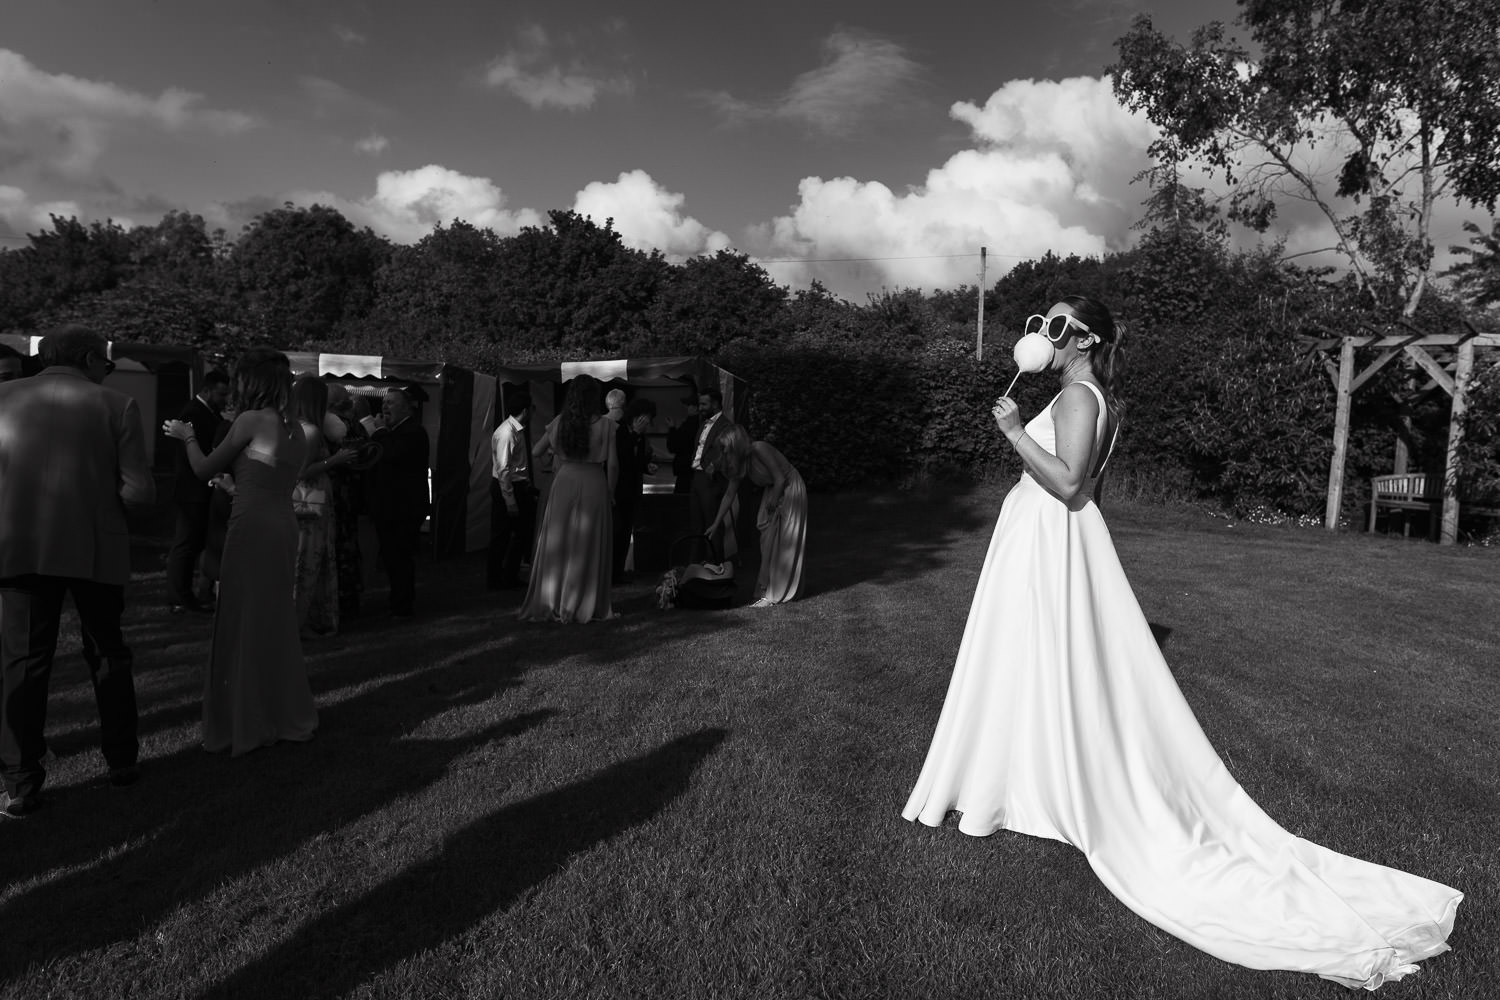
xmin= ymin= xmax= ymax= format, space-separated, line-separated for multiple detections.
xmin=203 ymin=729 xmax=728 ymax=997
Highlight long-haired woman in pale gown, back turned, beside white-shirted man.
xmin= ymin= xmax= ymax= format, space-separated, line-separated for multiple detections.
xmin=521 ymin=375 xmax=620 ymax=622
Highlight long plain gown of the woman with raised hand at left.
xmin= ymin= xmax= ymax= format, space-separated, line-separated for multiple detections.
xmin=203 ymin=447 xmax=318 ymax=756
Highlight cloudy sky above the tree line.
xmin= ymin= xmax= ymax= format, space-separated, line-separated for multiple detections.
xmin=0 ymin=0 xmax=1463 ymax=301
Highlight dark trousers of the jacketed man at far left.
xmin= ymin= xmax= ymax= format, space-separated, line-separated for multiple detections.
xmin=0 ymin=574 xmax=140 ymax=796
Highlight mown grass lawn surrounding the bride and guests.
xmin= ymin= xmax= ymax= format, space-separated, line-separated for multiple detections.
xmin=0 ymin=487 xmax=1500 ymax=1000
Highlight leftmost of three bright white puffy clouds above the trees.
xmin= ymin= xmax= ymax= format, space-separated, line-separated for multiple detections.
xmin=287 ymin=163 xmax=543 ymax=243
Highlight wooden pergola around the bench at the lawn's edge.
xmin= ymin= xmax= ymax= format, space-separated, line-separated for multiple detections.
xmin=1308 ymin=324 xmax=1500 ymax=546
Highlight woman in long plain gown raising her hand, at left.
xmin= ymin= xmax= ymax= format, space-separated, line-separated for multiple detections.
xmin=164 ymin=348 xmax=318 ymax=756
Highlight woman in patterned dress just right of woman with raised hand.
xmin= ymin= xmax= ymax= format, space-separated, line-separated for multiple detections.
xmin=291 ymin=375 xmax=354 ymax=639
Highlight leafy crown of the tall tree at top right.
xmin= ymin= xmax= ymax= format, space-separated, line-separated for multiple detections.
xmin=1110 ymin=0 xmax=1500 ymax=318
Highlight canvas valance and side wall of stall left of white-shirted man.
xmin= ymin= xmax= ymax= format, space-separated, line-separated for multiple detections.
xmin=287 ymin=352 xmax=495 ymax=558
